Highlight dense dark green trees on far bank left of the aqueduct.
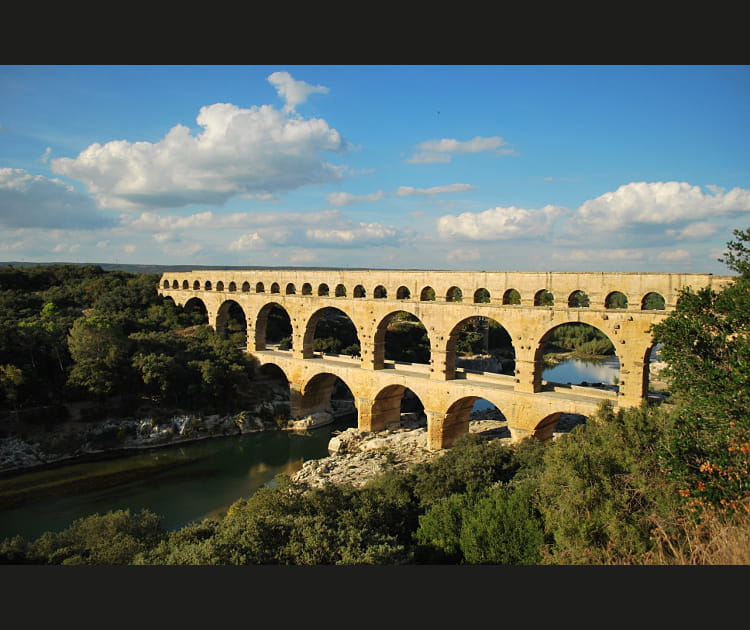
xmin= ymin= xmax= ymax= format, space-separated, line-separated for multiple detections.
xmin=0 ymin=265 xmax=262 ymax=417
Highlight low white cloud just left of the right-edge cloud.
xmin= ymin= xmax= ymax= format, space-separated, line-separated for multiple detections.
xmin=437 ymin=205 xmax=563 ymax=241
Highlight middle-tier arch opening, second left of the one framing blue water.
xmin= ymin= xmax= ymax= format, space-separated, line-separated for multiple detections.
xmin=373 ymin=310 xmax=432 ymax=366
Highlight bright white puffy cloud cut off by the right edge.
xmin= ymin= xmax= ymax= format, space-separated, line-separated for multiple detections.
xmin=574 ymin=182 xmax=750 ymax=232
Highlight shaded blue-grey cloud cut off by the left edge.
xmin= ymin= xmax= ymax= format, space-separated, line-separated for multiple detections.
xmin=0 ymin=168 xmax=114 ymax=230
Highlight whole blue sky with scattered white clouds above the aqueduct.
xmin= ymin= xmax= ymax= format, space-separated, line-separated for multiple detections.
xmin=0 ymin=65 xmax=750 ymax=274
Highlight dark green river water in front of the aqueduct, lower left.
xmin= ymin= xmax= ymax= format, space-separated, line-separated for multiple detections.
xmin=0 ymin=419 xmax=356 ymax=540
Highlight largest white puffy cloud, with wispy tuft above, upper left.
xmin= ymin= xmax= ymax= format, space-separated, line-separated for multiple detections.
xmin=51 ymin=73 xmax=348 ymax=210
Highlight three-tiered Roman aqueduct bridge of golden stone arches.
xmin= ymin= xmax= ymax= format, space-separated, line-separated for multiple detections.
xmin=159 ymin=268 xmax=732 ymax=449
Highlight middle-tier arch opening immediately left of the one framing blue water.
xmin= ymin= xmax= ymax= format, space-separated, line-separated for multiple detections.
xmin=445 ymin=315 xmax=516 ymax=380
